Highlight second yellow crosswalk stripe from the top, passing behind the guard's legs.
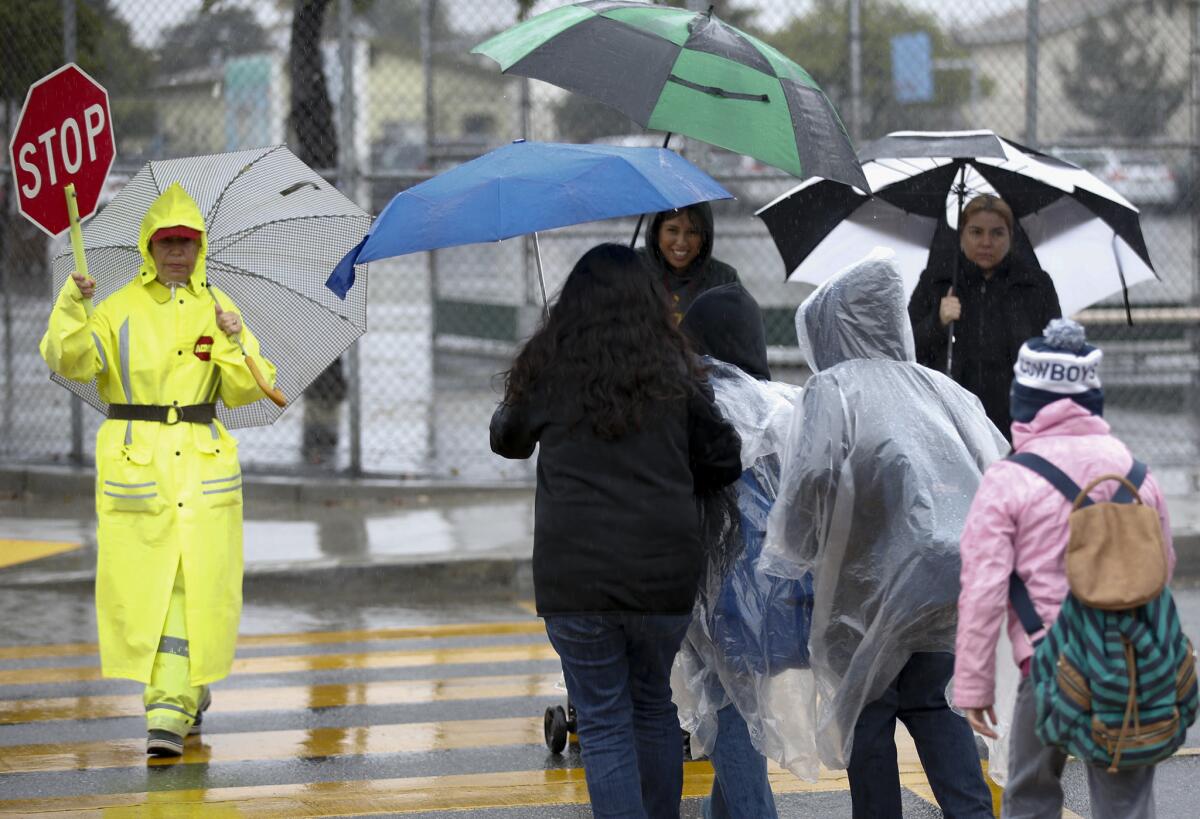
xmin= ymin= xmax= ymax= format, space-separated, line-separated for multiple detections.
xmin=0 ymin=642 xmax=558 ymax=686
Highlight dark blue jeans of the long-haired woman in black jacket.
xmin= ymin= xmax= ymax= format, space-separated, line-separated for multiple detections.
xmin=546 ymin=612 xmax=691 ymax=819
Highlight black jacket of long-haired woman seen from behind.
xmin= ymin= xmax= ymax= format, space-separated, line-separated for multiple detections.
xmin=491 ymin=381 xmax=742 ymax=616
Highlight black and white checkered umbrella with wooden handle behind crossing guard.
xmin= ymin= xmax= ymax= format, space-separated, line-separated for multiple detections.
xmin=53 ymin=145 xmax=371 ymax=429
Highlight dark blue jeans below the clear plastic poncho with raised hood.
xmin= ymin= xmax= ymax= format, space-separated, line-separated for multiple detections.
xmin=847 ymin=652 xmax=992 ymax=819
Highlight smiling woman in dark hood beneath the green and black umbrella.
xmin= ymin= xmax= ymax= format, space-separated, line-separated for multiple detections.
xmin=637 ymin=202 xmax=738 ymax=323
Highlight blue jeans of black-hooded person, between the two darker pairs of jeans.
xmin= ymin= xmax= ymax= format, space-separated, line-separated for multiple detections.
xmin=701 ymin=705 xmax=779 ymax=819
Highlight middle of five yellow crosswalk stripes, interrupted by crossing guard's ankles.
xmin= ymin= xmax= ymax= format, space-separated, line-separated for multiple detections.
xmin=0 ymin=674 xmax=563 ymax=725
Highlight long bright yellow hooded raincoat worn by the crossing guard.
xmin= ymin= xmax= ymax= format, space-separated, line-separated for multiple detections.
xmin=41 ymin=184 xmax=275 ymax=686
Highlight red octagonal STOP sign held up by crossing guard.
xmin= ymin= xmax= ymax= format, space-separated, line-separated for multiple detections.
xmin=8 ymin=62 xmax=116 ymax=237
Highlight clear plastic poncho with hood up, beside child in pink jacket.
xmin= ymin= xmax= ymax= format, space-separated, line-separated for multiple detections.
xmin=762 ymin=250 xmax=1008 ymax=769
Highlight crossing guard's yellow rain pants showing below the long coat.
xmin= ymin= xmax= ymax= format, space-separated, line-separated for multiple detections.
xmin=142 ymin=562 xmax=206 ymax=736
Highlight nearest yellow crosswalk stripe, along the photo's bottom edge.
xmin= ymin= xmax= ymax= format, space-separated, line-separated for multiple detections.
xmin=0 ymin=761 xmax=883 ymax=819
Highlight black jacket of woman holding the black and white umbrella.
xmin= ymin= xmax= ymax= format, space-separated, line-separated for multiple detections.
xmin=908 ymin=252 xmax=1062 ymax=440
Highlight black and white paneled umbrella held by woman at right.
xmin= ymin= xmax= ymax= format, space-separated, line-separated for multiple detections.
xmin=757 ymin=131 xmax=1158 ymax=316
